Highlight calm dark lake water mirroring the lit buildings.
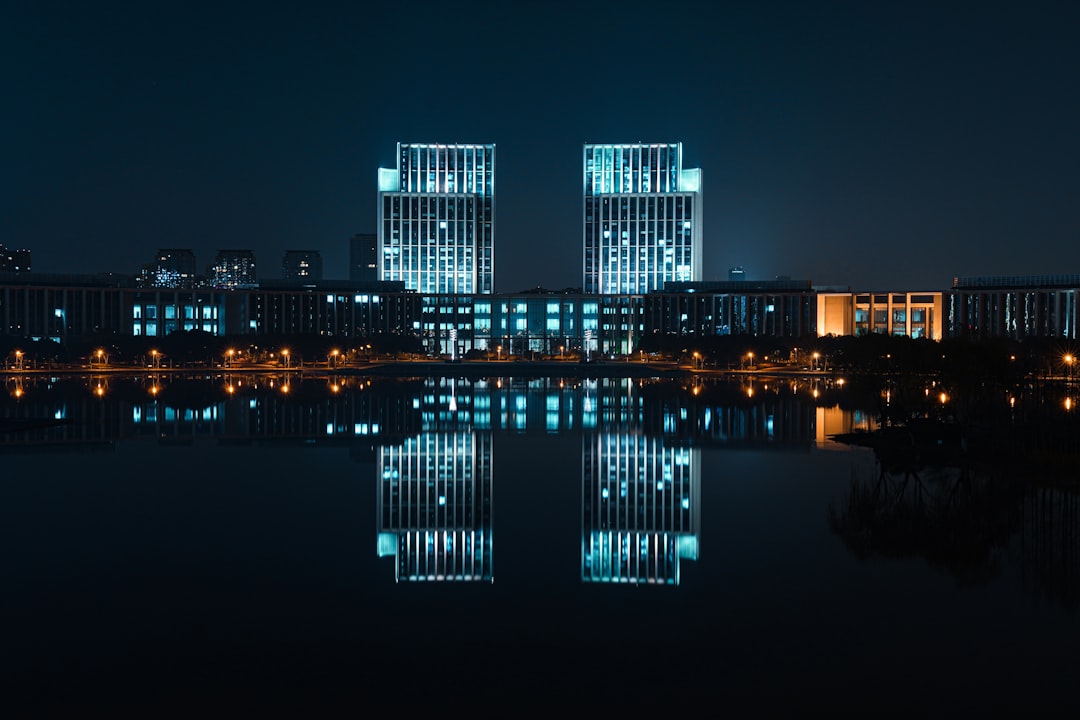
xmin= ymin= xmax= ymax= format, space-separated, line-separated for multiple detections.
xmin=0 ymin=376 xmax=1080 ymax=717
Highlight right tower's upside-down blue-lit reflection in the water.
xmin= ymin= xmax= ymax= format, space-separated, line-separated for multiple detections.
xmin=581 ymin=433 xmax=701 ymax=585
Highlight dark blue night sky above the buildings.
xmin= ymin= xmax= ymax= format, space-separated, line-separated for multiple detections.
xmin=0 ymin=0 xmax=1080 ymax=290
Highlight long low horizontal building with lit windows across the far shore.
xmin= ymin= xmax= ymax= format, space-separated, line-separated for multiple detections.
xmin=14 ymin=273 xmax=1080 ymax=357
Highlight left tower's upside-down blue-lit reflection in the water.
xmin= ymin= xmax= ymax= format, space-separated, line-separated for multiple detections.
xmin=377 ymin=431 xmax=494 ymax=582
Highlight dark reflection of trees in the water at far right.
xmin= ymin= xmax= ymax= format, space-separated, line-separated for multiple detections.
xmin=829 ymin=451 xmax=1080 ymax=610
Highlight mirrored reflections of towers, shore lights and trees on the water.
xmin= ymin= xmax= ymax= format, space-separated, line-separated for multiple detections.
xmin=0 ymin=372 xmax=1080 ymax=608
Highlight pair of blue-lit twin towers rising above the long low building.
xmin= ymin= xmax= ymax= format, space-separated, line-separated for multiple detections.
xmin=377 ymin=142 xmax=702 ymax=295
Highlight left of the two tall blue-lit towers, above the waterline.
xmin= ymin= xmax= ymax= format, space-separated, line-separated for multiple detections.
xmin=378 ymin=142 xmax=495 ymax=294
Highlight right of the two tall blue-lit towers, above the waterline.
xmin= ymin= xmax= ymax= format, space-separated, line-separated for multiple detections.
xmin=582 ymin=142 xmax=702 ymax=294
